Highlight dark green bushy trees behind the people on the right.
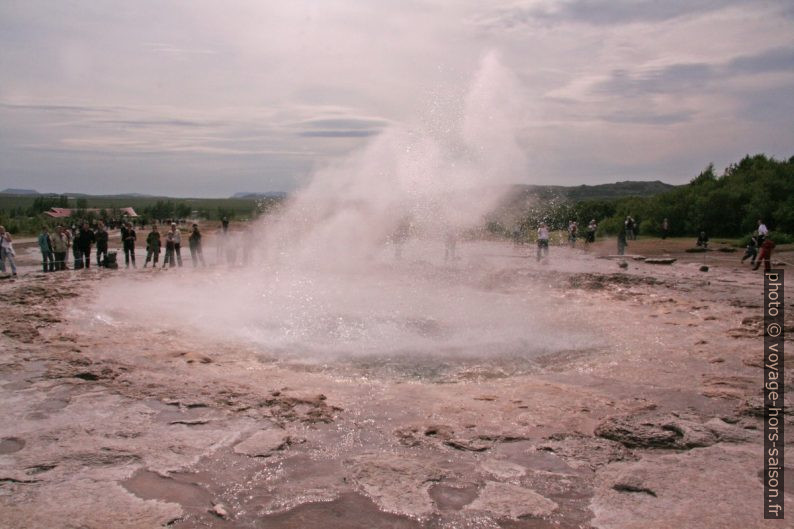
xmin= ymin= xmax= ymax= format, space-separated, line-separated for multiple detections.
xmin=498 ymin=154 xmax=794 ymax=243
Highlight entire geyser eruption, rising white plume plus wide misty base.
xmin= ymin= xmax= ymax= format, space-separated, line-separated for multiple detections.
xmin=85 ymin=54 xmax=592 ymax=369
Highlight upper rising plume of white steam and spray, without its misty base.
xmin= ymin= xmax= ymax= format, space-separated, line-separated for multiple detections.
xmin=258 ymin=52 xmax=527 ymax=265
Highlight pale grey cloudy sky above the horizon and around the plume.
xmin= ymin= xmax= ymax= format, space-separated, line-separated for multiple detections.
xmin=0 ymin=0 xmax=794 ymax=196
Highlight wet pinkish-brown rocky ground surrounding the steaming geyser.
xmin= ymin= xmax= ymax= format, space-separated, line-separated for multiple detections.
xmin=0 ymin=239 xmax=794 ymax=529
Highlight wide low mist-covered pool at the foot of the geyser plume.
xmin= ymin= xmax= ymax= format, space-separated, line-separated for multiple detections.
xmin=86 ymin=242 xmax=604 ymax=376
